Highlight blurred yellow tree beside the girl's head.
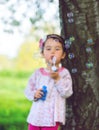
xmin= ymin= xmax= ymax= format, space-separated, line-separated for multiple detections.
xmin=16 ymin=41 xmax=45 ymax=71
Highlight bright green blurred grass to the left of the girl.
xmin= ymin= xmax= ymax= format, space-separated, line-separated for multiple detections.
xmin=0 ymin=71 xmax=31 ymax=130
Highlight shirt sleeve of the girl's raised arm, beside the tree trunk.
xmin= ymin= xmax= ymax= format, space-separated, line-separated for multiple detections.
xmin=55 ymin=69 xmax=73 ymax=98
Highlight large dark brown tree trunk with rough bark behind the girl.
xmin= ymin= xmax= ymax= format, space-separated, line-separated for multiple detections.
xmin=59 ymin=0 xmax=99 ymax=130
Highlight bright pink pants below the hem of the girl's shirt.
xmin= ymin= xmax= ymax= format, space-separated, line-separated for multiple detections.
xmin=28 ymin=123 xmax=60 ymax=130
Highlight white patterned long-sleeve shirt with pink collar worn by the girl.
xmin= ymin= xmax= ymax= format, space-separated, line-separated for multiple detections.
xmin=25 ymin=68 xmax=73 ymax=126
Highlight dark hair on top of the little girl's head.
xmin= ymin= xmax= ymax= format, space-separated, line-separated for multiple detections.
xmin=42 ymin=34 xmax=66 ymax=52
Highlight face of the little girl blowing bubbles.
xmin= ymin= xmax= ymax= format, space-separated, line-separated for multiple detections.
xmin=43 ymin=38 xmax=66 ymax=65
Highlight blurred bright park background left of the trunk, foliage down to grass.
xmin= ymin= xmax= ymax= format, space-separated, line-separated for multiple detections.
xmin=0 ymin=0 xmax=60 ymax=130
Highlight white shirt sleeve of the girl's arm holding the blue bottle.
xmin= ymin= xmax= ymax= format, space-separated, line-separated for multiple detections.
xmin=24 ymin=72 xmax=36 ymax=101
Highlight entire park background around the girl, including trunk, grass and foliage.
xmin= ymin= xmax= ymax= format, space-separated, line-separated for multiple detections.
xmin=0 ymin=0 xmax=99 ymax=130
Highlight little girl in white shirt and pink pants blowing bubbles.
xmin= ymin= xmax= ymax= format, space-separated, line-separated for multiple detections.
xmin=25 ymin=34 xmax=73 ymax=130
